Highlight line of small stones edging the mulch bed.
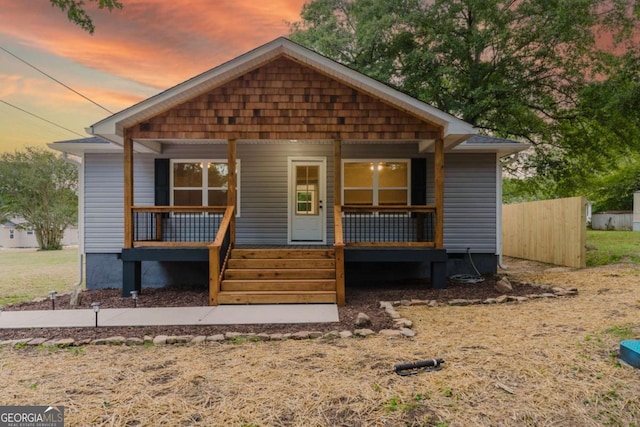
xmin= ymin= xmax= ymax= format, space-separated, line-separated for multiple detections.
xmin=0 ymin=285 xmax=578 ymax=348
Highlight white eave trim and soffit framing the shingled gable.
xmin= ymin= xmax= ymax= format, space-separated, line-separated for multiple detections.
xmin=87 ymin=37 xmax=477 ymax=147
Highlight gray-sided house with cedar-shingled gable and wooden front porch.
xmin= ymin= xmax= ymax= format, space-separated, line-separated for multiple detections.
xmin=50 ymin=38 xmax=527 ymax=305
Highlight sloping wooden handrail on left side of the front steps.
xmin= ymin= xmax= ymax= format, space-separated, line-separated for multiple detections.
xmin=209 ymin=206 xmax=235 ymax=305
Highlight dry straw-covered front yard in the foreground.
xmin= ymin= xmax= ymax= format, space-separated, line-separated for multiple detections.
xmin=0 ymin=264 xmax=640 ymax=427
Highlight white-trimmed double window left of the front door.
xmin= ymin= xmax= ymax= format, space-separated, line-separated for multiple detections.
xmin=171 ymin=159 xmax=240 ymax=215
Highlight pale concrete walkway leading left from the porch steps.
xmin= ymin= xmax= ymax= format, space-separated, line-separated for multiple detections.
xmin=0 ymin=304 xmax=339 ymax=329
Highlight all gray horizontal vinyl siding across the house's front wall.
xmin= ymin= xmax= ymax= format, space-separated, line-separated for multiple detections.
xmin=84 ymin=142 xmax=496 ymax=253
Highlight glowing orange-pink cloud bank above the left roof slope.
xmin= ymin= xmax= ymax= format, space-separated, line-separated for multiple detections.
xmin=1 ymin=0 xmax=304 ymax=89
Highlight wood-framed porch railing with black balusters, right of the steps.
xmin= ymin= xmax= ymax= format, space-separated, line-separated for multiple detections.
xmin=335 ymin=205 xmax=436 ymax=247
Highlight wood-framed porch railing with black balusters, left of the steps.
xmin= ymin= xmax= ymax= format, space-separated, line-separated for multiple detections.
xmin=132 ymin=206 xmax=227 ymax=247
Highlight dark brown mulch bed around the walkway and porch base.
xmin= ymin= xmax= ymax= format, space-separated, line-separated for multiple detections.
xmin=0 ymin=276 xmax=541 ymax=340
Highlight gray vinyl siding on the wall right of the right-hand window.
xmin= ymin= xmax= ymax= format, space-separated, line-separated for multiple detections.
xmin=427 ymin=153 xmax=497 ymax=254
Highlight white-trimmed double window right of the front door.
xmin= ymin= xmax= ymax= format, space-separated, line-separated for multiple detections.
xmin=342 ymin=159 xmax=411 ymax=206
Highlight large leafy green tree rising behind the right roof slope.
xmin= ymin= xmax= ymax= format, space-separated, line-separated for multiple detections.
xmin=290 ymin=0 xmax=638 ymax=174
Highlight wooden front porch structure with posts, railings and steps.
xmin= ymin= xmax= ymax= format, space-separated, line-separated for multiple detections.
xmin=121 ymin=139 xmax=446 ymax=305
